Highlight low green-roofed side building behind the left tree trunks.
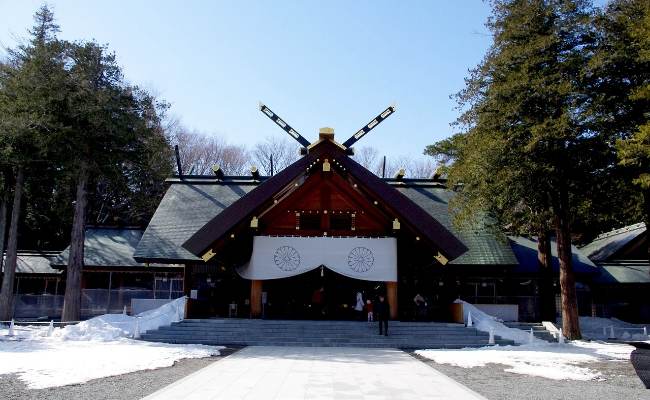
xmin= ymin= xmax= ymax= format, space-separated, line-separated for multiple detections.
xmin=0 ymin=227 xmax=184 ymax=320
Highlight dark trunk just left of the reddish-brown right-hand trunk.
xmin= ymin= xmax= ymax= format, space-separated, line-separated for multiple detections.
xmin=537 ymin=227 xmax=556 ymax=322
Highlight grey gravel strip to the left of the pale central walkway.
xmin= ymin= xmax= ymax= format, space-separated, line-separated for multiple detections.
xmin=0 ymin=349 xmax=236 ymax=400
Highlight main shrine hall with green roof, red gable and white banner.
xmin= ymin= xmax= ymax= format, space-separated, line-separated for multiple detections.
xmin=134 ymin=132 xmax=595 ymax=320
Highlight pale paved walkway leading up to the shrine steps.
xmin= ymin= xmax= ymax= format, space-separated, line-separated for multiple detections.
xmin=145 ymin=347 xmax=485 ymax=400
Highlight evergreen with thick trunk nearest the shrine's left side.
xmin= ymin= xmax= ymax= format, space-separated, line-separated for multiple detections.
xmin=55 ymin=42 xmax=171 ymax=321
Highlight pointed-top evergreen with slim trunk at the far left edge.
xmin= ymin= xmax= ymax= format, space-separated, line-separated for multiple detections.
xmin=0 ymin=6 xmax=66 ymax=320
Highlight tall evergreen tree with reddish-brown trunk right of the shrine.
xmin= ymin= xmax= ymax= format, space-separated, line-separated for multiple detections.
xmin=428 ymin=0 xmax=601 ymax=339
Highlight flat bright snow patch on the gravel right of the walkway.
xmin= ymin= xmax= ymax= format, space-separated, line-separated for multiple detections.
xmin=416 ymin=341 xmax=634 ymax=380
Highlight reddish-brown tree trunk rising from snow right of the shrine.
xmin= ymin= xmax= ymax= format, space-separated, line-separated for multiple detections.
xmin=555 ymin=188 xmax=582 ymax=340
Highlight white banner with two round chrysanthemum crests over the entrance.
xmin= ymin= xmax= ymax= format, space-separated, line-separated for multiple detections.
xmin=237 ymin=236 xmax=397 ymax=282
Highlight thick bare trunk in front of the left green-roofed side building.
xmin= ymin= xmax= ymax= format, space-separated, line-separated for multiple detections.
xmin=61 ymin=166 xmax=88 ymax=322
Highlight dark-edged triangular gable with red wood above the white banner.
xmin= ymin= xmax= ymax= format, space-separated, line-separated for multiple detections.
xmin=183 ymin=139 xmax=467 ymax=264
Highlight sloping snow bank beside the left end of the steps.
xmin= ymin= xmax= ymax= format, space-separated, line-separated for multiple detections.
xmin=54 ymin=297 xmax=187 ymax=340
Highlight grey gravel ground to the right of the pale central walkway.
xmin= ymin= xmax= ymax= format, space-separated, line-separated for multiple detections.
xmin=413 ymin=355 xmax=650 ymax=400
